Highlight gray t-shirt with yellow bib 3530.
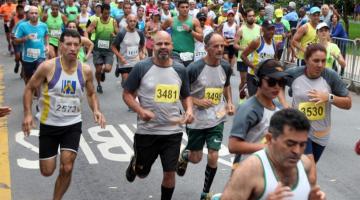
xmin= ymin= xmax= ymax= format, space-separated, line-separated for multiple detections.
xmin=285 ymin=67 xmax=349 ymax=146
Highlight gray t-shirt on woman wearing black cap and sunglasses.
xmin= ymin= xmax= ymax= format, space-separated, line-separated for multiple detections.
xmin=230 ymin=96 xmax=282 ymax=163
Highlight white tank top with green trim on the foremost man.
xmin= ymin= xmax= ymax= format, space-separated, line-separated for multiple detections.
xmin=255 ymin=149 xmax=310 ymax=200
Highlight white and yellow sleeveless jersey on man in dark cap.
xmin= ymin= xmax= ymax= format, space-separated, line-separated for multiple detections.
xmin=248 ymin=37 xmax=275 ymax=75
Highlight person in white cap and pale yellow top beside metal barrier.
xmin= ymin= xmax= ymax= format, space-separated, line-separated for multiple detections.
xmin=316 ymin=22 xmax=346 ymax=72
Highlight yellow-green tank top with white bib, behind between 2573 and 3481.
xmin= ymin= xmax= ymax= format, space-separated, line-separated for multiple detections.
xmin=94 ymin=17 xmax=115 ymax=52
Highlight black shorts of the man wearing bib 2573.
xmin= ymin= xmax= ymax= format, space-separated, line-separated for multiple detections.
xmin=39 ymin=122 xmax=82 ymax=160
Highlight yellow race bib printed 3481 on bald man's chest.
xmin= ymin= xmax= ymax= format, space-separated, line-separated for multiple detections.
xmin=154 ymin=84 xmax=179 ymax=103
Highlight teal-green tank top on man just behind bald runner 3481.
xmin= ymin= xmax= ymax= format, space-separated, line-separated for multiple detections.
xmin=171 ymin=17 xmax=195 ymax=53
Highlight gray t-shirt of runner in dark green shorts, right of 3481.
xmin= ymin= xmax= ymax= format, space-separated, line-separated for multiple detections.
xmin=187 ymin=59 xmax=232 ymax=129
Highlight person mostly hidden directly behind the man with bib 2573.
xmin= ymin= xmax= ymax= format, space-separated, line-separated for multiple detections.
xmin=66 ymin=21 xmax=94 ymax=63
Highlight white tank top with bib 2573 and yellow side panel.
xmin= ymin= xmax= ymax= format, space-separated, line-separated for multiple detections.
xmin=39 ymin=57 xmax=85 ymax=126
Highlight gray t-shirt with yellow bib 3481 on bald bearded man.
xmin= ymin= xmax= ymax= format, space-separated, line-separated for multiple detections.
xmin=124 ymin=58 xmax=190 ymax=135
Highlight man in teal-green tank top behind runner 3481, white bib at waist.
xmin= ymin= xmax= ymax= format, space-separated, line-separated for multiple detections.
xmin=162 ymin=0 xmax=203 ymax=67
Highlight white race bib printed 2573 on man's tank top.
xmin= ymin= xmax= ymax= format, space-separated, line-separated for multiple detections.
xmin=55 ymin=97 xmax=81 ymax=116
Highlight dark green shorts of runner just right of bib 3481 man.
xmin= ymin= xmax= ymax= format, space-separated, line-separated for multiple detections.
xmin=186 ymin=122 xmax=224 ymax=151
